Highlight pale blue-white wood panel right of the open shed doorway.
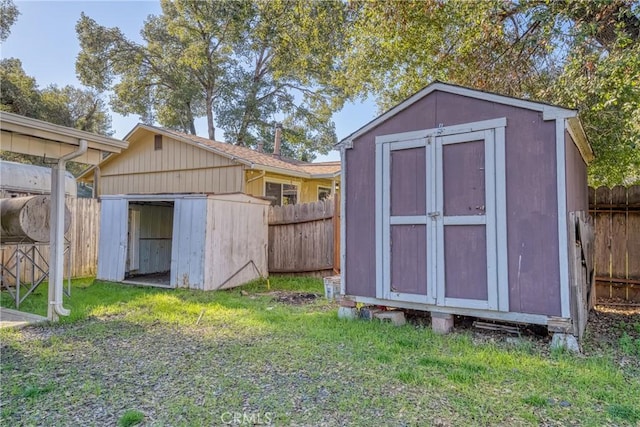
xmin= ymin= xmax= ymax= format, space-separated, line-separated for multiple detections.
xmin=171 ymin=198 xmax=207 ymax=289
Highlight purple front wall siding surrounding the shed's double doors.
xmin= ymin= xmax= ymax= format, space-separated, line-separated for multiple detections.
xmin=345 ymin=91 xmax=560 ymax=316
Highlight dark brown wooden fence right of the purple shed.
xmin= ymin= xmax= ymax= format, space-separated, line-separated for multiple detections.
xmin=589 ymin=185 xmax=640 ymax=302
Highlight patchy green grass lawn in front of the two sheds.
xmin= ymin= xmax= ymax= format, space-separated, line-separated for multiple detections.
xmin=0 ymin=278 xmax=640 ymax=426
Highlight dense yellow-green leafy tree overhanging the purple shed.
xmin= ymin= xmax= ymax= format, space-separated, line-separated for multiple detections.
xmin=337 ymin=0 xmax=640 ymax=184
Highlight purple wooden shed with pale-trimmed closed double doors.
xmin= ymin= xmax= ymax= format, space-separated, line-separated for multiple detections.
xmin=340 ymin=82 xmax=593 ymax=340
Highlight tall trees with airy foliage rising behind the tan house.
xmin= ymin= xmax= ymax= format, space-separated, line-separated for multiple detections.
xmin=76 ymin=0 xmax=346 ymax=160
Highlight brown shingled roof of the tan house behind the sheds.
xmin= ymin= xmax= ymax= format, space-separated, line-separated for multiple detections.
xmin=80 ymin=123 xmax=340 ymax=178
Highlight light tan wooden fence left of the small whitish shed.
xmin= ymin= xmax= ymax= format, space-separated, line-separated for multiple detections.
xmin=0 ymin=197 xmax=100 ymax=282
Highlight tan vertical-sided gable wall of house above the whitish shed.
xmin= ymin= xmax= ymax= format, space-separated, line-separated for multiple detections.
xmin=98 ymin=132 xmax=244 ymax=195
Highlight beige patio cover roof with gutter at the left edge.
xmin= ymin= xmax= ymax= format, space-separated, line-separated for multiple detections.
xmin=0 ymin=112 xmax=128 ymax=165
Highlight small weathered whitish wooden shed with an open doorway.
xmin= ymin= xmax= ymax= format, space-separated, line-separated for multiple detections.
xmin=97 ymin=193 xmax=269 ymax=290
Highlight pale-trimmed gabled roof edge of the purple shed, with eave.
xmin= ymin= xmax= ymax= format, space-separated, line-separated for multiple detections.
xmin=337 ymin=81 xmax=594 ymax=163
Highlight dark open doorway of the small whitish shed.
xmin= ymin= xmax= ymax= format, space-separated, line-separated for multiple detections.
xmin=125 ymin=200 xmax=174 ymax=287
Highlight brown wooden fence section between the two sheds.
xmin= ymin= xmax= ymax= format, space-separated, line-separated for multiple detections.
xmin=269 ymin=196 xmax=340 ymax=276
